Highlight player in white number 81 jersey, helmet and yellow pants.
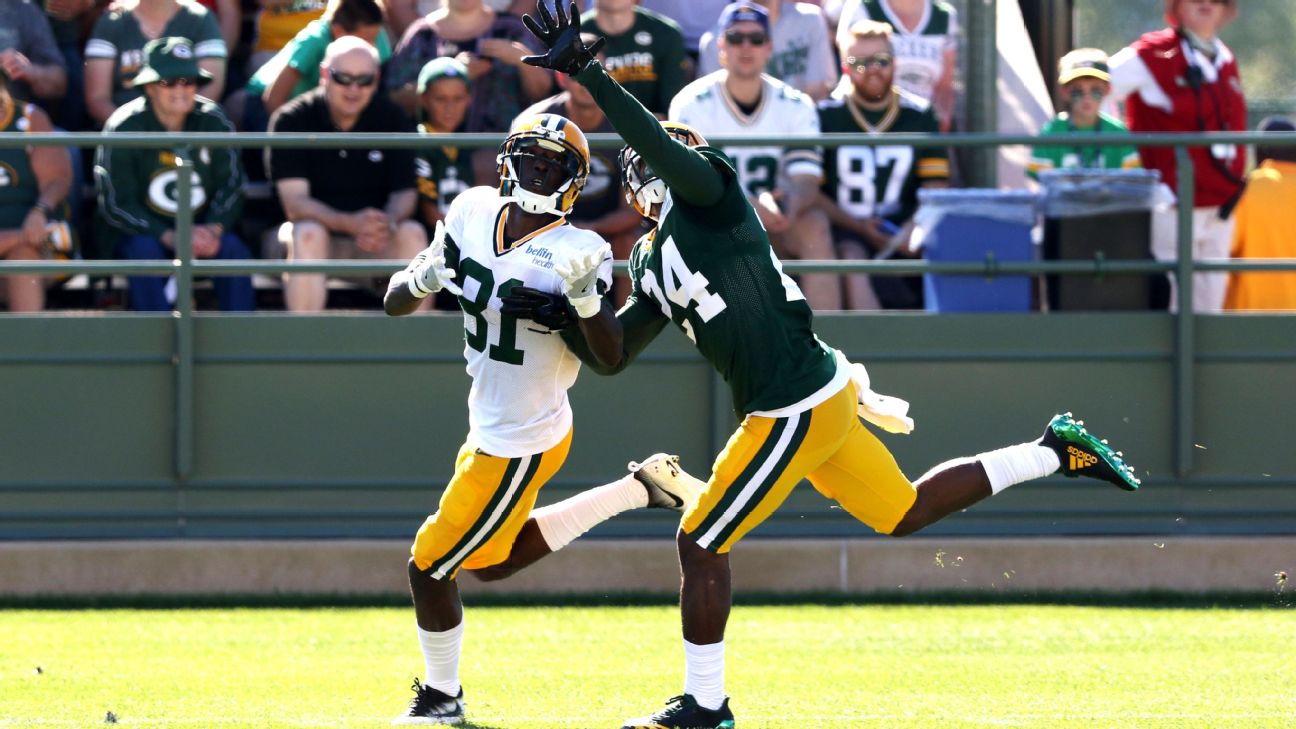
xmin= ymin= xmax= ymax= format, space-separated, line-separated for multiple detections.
xmin=384 ymin=114 xmax=701 ymax=725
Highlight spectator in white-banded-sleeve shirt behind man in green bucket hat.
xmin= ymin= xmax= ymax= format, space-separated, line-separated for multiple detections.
xmin=86 ymin=0 xmax=228 ymax=126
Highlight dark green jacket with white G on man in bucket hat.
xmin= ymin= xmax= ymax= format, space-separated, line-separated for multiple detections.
xmin=95 ymin=97 xmax=244 ymax=236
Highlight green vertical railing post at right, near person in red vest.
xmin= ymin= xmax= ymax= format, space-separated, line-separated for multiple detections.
xmin=1174 ymin=144 xmax=1196 ymax=477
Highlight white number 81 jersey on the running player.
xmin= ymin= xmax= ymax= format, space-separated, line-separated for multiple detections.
xmin=446 ymin=187 xmax=612 ymax=458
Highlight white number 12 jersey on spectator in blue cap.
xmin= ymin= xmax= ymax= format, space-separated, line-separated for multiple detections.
xmin=667 ymin=69 xmax=823 ymax=195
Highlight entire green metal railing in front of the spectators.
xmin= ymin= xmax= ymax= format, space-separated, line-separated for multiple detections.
xmin=0 ymin=132 xmax=1296 ymax=480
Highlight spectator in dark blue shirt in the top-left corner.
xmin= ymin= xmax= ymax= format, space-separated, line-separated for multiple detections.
xmin=0 ymin=0 xmax=67 ymax=113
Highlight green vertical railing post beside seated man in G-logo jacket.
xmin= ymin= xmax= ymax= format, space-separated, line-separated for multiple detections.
xmin=172 ymin=147 xmax=193 ymax=487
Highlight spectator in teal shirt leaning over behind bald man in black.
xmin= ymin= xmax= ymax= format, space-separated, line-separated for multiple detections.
xmin=242 ymin=0 xmax=391 ymax=131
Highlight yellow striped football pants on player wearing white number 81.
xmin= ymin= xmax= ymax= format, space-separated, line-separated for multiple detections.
xmin=410 ymin=431 xmax=572 ymax=580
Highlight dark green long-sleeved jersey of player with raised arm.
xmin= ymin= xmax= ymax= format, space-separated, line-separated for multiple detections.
xmin=569 ymin=64 xmax=845 ymax=416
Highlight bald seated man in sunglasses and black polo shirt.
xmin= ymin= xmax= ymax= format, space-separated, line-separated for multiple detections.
xmin=266 ymin=35 xmax=428 ymax=311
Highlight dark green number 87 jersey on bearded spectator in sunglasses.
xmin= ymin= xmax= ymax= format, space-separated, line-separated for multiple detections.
xmin=819 ymin=92 xmax=950 ymax=224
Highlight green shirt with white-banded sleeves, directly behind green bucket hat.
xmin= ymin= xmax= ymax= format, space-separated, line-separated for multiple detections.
xmin=86 ymin=0 xmax=228 ymax=106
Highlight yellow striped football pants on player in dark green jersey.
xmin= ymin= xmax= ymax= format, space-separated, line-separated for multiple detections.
xmin=680 ymin=383 xmax=918 ymax=554
